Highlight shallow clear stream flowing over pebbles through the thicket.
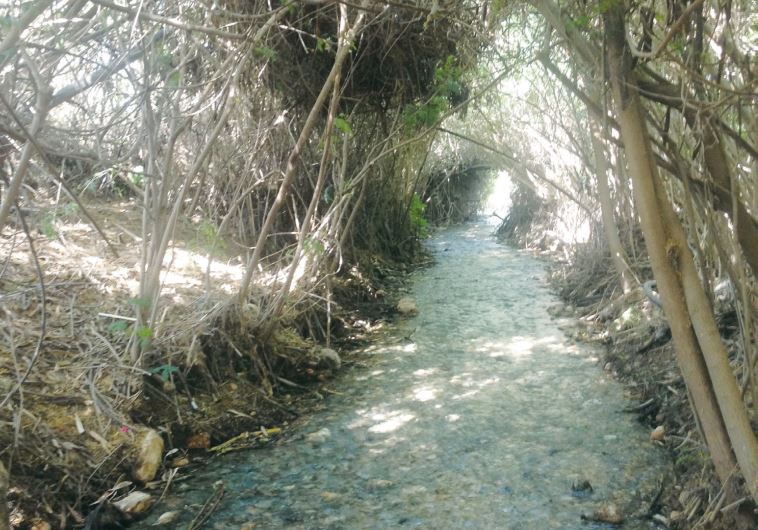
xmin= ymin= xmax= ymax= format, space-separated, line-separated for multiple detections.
xmin=140 ymin=224 xmax=665 ymax=529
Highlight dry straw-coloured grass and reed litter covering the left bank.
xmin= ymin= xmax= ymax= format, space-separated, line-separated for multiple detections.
xmin=0 ymin=197 xmax=338 ymax=527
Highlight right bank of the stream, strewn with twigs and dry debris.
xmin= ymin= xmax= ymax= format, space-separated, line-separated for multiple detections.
xmin=506 ymin=228 xmax=758 ymax=530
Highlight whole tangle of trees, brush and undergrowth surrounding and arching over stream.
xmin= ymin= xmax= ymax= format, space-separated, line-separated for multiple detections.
xmin=0 ymin=0 xmax=758 ymax=527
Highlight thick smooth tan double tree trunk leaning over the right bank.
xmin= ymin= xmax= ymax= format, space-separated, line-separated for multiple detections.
xmin=604 ymin=2 xmax=758 ymax=500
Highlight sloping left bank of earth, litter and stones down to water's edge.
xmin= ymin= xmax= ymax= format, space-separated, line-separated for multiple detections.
xmin=0 ymin=202 xmax=422 ymax=530
